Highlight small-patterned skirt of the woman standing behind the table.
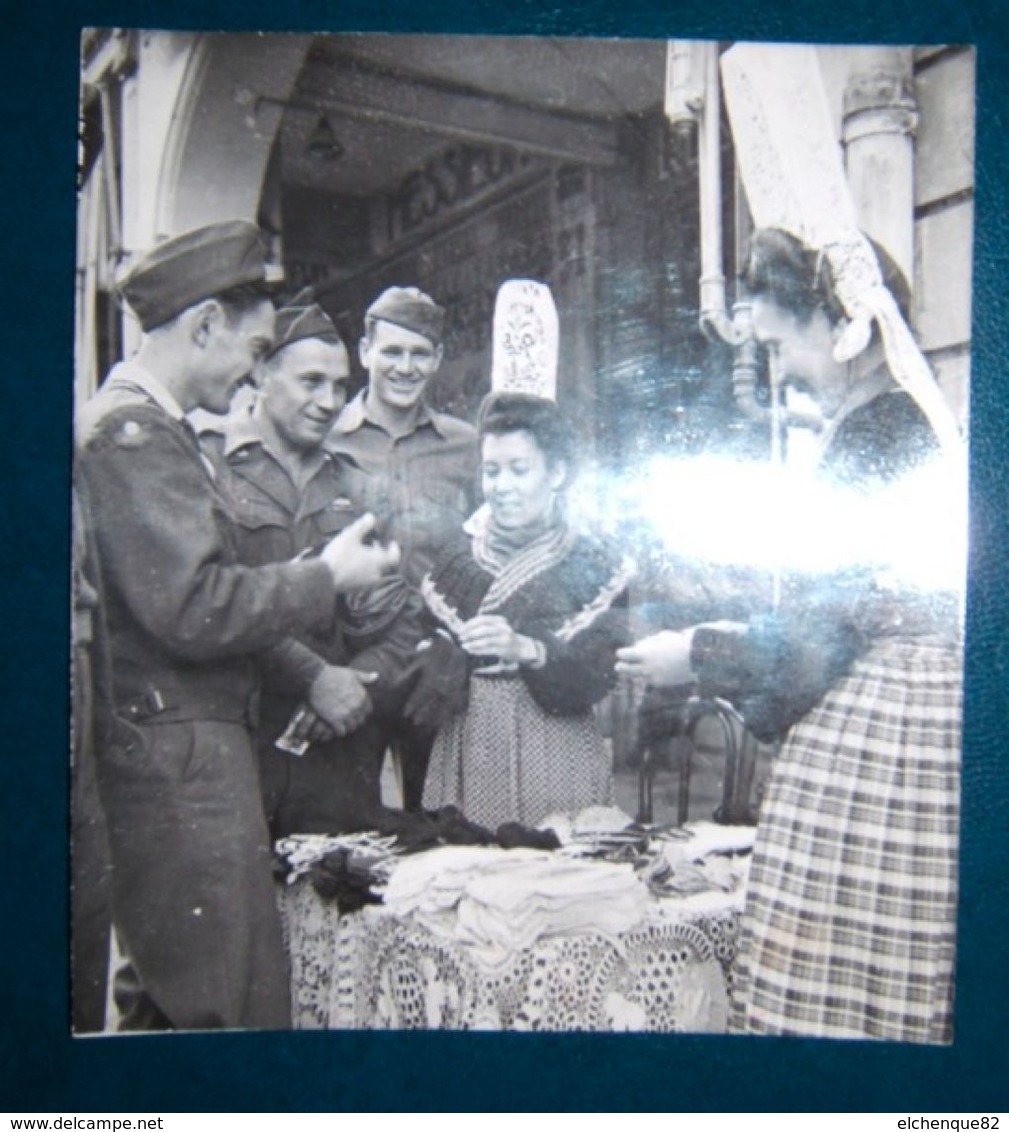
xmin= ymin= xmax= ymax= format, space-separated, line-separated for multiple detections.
xmin=424 ymin=675 xmax=614 ymax=830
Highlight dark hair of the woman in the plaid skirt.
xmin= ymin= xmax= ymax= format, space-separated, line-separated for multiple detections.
xmin=739 ymin=228 xmax=910 ymax=324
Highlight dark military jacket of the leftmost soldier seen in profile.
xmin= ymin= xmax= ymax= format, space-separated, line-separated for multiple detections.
xmin=77 ymin=362 xmax=335 ymax=722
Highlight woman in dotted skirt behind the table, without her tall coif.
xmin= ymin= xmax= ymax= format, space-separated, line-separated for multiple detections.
xmin=407 ymin=393 xmax=632 ymax=829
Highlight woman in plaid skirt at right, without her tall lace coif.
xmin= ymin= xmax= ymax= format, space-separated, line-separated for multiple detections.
xmin=618 ymin=230 xmax=961 ymax=1043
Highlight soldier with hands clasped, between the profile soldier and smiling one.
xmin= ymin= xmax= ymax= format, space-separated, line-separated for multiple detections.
xmin=200 ymin=292 xmax=422 ymax=838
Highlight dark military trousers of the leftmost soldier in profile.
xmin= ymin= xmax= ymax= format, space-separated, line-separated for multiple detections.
xmin=100 ymin=720 xmax=291 ymax=1030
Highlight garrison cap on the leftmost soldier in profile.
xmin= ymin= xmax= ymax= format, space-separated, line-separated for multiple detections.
xmin=119 ymin=220 xmax=276 ymax=331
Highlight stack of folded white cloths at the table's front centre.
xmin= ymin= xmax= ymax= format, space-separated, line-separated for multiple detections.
xmin=375 ymin=846 xmax=650 ymax=964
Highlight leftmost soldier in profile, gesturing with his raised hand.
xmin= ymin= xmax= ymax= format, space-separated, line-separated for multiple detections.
xmin=77 ymin=221 xmax=397 ymax=1029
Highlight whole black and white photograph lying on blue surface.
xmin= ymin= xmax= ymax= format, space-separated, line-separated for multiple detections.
xmin=69 ymin=27 xmax=975 ymax=1046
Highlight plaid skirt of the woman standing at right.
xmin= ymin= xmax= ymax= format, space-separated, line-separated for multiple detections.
xmin=730 ymin=640 xmax=963 ymax=1043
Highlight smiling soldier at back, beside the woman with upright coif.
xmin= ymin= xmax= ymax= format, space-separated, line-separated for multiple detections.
xmin=328 ymin=286 xmax=479 ymax=809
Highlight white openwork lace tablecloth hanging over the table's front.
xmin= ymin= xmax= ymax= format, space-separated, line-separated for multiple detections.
xmin=281 ymin=855 xmax=739 ymax=1032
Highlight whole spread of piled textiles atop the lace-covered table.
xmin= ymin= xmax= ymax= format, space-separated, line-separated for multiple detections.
xmin=276 ymin=807 xmax=754 ymax=932
